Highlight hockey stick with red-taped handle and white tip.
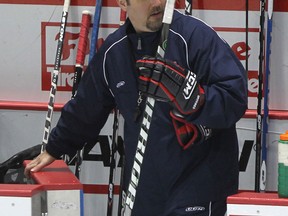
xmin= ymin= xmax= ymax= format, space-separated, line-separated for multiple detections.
xmin=71 ymin=10 xmax=91 ymax=179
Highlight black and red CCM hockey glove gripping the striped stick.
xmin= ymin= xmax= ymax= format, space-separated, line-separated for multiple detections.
xmin=136 ymin=57 xmax=205 ymax=115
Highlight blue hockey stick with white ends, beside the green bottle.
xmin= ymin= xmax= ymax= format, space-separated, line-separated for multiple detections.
xmin=260 ymin=0 xmax=273 ymax=191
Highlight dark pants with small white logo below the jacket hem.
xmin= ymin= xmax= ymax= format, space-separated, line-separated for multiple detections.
xmin=169 ymin=200 xmax=227 ymax=216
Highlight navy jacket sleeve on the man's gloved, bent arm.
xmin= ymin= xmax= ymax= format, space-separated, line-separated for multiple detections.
xmin=189 ymin=26 xmax=247 ymax=128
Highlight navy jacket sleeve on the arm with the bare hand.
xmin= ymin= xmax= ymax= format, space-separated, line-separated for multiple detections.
xmin=46 ymin=56 xmax=115 ymax=158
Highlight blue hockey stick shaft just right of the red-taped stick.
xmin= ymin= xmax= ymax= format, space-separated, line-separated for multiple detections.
xmin=89 ymin=0 xmax=102 ymax=62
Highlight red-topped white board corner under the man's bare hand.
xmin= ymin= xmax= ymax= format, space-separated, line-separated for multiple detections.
xmin=0 ymin=160 xmax=84 ymax=216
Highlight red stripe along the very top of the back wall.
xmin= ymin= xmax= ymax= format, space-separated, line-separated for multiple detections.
xmin=0 ymin=0 xmax=288 ymax=12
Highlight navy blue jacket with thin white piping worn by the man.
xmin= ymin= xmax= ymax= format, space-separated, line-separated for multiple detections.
xmin=47 ymin=11 xmax=247 ymax=216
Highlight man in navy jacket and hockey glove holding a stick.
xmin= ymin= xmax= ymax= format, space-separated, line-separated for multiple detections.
xmin=25 ymin=0 xmax=247 ymax=216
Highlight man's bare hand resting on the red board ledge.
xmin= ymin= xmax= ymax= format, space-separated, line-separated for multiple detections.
xmin=24 ymin=151 xmax=56 ymax=178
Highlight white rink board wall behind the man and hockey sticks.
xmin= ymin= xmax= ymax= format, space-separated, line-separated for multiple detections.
xmin=0 ymin=1 xmax=288 ymax=216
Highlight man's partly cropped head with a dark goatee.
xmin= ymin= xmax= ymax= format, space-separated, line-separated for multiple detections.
xmin=117 ymin=0 xmax=166 ymax=33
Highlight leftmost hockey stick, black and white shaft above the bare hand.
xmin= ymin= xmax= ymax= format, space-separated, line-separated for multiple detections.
xmin=41 ymin=0 xmax=70 ymax=152
